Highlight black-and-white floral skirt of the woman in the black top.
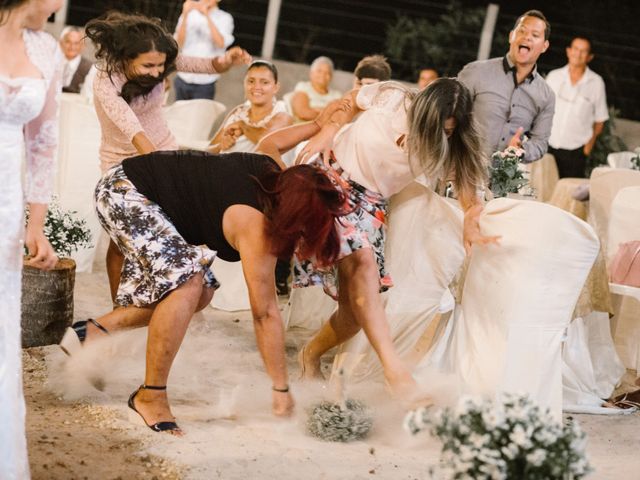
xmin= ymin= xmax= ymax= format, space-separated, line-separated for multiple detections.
xmin=95 ymin=166 xmax=220 ymax=307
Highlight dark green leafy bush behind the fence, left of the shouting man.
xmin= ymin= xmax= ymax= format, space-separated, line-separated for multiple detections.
xmin=386 ymin=1 xmax=485 ymax=78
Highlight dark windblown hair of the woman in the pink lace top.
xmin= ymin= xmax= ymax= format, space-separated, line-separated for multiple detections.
xmin=85 ymin=12 xmax=178 ymax=93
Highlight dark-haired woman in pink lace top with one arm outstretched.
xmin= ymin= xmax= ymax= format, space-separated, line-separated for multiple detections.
xmin=85 ymin=12 xmax=251 ymax=299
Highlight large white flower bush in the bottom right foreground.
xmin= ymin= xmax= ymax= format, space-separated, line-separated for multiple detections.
xmin=404 ymin=394 xmax=592 ymax=480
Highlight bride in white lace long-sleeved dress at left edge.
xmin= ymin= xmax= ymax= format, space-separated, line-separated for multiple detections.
xmin=0 ymin=0 xmax=62 ymax=474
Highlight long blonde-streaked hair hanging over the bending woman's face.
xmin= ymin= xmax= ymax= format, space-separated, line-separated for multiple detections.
xmin=407 ymin=78 xmax=487 ymax=192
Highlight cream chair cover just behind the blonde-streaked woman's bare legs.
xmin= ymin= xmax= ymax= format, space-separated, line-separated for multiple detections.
xmin=332 ymin=182 xmax=464 ymax=382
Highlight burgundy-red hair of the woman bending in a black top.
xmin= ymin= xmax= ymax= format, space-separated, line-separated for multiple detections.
xmin=258 ymin=165 xmax=347 ymax=265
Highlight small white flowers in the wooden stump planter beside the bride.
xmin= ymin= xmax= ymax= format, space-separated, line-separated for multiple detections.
xmin=25 ymin=197 xmax=92 ymax=257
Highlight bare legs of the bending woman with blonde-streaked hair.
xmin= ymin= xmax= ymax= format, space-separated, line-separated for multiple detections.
xmin=304 ymin=248 xmax=415 ymax=394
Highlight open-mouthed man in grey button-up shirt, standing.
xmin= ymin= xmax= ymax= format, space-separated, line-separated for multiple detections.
xmin=458 ymin=10 xmax=555 ymax=162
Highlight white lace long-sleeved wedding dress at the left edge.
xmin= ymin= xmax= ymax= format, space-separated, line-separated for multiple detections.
xmin=0 ymin=31 xmax=62 ymax=480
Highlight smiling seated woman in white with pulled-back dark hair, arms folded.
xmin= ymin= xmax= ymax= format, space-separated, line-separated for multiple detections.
xmin=209 ymin=60 xmax=293 ymax=153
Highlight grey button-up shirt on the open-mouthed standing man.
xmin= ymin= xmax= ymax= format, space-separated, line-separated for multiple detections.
xmin=458 ymin=55 xmax=555 ymax=162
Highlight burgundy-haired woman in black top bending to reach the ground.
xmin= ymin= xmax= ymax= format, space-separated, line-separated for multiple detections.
xmin=60 ymin=107 xmax=345 ymax=435
